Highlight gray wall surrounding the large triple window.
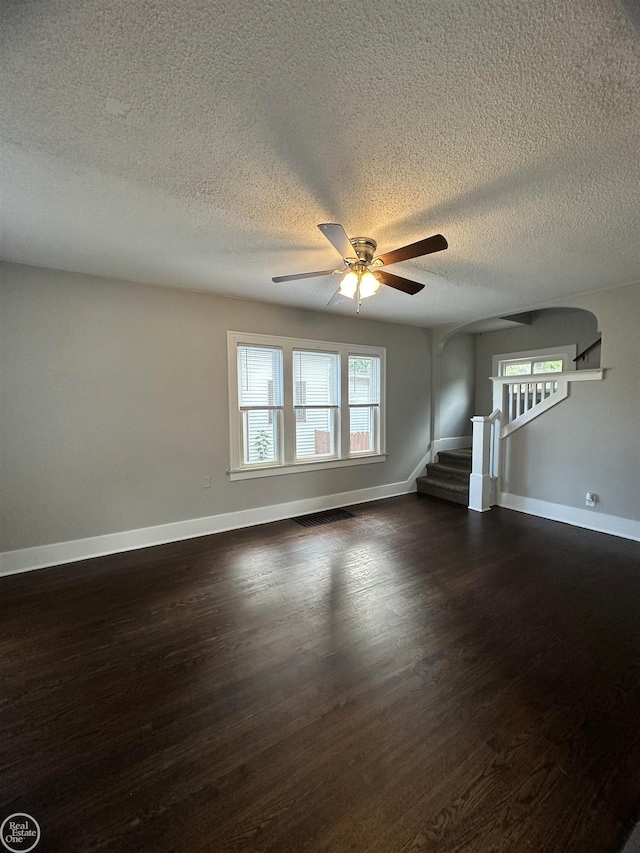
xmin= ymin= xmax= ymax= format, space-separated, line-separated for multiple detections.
xmin=0 ymin=264 xmax=431 ymax=551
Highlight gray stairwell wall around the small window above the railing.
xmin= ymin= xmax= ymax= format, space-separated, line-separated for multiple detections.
xmin=474 ymin=307 xmax=601 ymax=415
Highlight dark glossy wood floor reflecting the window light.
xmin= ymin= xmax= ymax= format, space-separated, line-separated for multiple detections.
xmin=0 ymin=495 xmax=640 ymax=853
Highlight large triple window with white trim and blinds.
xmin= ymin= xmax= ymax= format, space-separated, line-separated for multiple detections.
xmin=227 ymin=332 xmax=385 ymax=480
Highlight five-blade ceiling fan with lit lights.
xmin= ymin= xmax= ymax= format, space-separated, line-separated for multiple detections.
xmin=272 ymin=222 xmax=449 ymax=313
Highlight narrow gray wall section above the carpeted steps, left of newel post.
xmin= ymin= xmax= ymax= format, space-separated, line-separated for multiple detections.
xmin=435 ymin=332 xmax=476 ymax=438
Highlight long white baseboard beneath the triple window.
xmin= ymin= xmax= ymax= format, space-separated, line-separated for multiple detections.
xmin=0 ymin=476 xmax=418 ymax=577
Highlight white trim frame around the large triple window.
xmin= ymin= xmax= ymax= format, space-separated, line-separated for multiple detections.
xmin=227 ymin=332 xmax=387 ymax=481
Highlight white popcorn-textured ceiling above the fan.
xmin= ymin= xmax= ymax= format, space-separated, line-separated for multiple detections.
xmin=0 ymin=0 xmax=640 ymax=326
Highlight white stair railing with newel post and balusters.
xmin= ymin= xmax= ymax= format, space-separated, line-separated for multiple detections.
xmin=469 ymin=368 xmax=604 ymax=512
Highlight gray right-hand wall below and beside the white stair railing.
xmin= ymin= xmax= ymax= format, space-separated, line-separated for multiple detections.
xmin=500 ymin=282 xmax=640 ymax=519
